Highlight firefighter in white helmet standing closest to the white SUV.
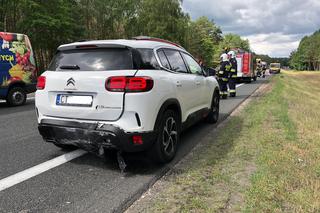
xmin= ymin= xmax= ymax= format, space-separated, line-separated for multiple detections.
xmin=218 ymin=53 xmax=231 ymax=99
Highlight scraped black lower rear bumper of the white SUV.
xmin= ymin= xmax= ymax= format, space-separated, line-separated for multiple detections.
xmin=38 ymin=119 xmax=156 ymax=153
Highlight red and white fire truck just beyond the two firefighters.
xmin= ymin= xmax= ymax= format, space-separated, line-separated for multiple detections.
xmin=237 ymin=51 xmax=257 ymax=83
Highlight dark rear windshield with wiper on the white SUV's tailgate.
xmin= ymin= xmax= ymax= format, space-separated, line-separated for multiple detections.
xmin=48 ymin=48 xmax=133 ymax=71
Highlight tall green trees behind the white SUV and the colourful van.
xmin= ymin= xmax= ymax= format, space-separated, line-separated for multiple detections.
xmin=0 ymin=0 xmax=250 ymax=70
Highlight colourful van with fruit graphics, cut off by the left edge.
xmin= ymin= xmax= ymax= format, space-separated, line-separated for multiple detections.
xmin=0 ymin=32 xmax=37 ymax=106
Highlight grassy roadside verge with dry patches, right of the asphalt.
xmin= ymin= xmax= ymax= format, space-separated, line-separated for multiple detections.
xmin=129 ymin=72 xmax=320 ymax=212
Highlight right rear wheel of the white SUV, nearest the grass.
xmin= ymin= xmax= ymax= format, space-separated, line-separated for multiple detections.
xmin=150 ymin=110 xmax=180 ymax=163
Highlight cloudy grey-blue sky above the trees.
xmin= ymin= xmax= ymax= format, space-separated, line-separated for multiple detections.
xmin=182 ymin=0 xmax=320 ymax=57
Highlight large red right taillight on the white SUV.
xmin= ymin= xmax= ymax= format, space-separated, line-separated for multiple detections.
xmin=105 ymin=76 xmax=153 ymax=92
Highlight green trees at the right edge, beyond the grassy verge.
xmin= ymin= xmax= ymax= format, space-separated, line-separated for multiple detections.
xmin=290 ymin=30 xmax=320 ymax=70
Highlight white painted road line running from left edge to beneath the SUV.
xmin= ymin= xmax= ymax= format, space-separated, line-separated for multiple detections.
xmin=0 ymin=149 xmax=87 ymax=192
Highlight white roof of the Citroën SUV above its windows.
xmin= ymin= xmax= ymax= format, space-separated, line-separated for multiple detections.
xmin=58 ymin=39 xmax=185 ymax=51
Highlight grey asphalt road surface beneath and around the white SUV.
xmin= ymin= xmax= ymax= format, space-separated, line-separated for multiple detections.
xmin=0 ymin=77 xmax=266 ymax=213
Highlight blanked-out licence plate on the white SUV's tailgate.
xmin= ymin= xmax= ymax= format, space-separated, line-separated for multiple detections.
xmin=56 ymin=94 xmax=93 ymax=107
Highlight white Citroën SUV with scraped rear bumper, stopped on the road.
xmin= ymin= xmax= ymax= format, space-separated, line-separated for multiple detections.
xmin=35 ymin=37 xmax=220 ymax=162
